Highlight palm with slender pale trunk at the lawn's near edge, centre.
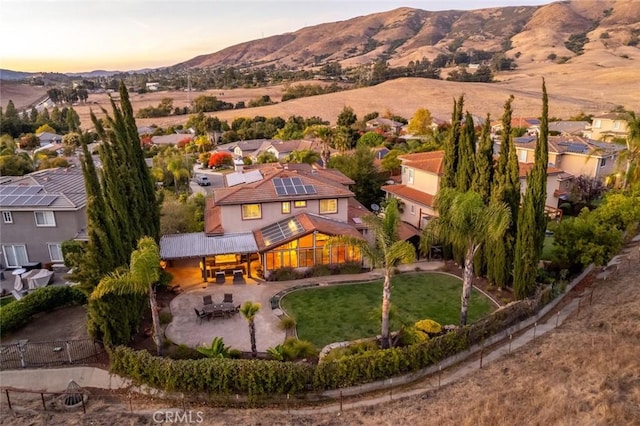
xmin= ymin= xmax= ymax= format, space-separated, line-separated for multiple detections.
xmin=326 ymin=198 xmax=416 ymax=349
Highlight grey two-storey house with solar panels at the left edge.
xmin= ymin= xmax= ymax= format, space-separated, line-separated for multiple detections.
xmin=0 ymin=167 xmax=87 ymax=268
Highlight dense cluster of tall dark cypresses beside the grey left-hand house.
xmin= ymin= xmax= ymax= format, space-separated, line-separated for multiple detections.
xmin=77 ymin=84 xmax=160 ymax=291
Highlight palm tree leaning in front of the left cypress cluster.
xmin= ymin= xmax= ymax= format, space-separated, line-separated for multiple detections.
xmin=90 ymin=237 xmax=162 ymax=355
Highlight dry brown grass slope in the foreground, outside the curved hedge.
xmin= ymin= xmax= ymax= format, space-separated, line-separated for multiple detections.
xmin=0 ymin=254 xmax=640 ymax=426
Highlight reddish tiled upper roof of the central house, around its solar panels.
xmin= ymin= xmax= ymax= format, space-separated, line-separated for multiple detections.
xmin=213 ymin=167 xmax=353 ymax=205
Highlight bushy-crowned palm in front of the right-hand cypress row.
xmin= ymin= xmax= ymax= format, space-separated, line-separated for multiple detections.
xmin=420 ymin=188 xmax=510 ymax=325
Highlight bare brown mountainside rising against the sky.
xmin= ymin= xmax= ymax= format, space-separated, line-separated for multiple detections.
xmin=176 ymin=0 xmax=640 ymax=68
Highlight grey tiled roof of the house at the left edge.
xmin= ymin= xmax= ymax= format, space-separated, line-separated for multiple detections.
xmin=0 ymin=167 xmax=87 ymax=210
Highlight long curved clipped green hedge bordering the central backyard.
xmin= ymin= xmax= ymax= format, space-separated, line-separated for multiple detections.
xmin=110 ymin=300 xmax=539 ymax=396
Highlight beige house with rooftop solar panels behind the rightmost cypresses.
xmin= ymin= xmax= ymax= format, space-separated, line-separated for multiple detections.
xmin=504 ymin=136 xmax=626 ymax=182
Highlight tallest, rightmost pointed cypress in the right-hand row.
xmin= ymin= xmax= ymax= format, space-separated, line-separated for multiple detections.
xmin=513 ymin=80 xmax=549 ymax=299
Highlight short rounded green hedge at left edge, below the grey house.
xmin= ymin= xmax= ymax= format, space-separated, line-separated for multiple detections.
xmin=0 ymin=286 xmax=87 ymax=334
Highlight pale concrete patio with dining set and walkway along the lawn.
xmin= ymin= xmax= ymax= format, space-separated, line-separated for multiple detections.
xmin=165 ymin=261 xmax=443 ymax=352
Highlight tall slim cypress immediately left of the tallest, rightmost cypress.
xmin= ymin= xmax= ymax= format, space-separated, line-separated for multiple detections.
xmin=486 ymin=96 xmax=520 ymax=288
